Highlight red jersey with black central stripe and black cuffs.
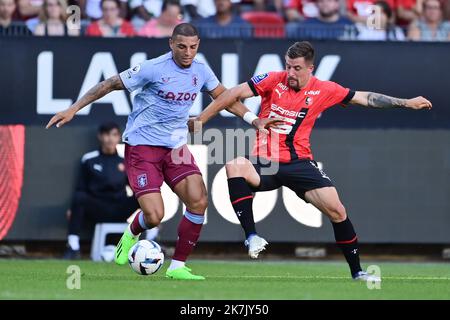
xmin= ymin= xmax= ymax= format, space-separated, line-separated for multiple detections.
xmin=248 ymin=71 xmax=355 ymax=162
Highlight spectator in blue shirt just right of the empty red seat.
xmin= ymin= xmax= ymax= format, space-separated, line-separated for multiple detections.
xmin=286 ymin=0 xmax=354 ymax=39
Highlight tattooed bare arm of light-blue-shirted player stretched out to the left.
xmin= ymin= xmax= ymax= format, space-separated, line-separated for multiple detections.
xmin=45 ymin=75 xmax=125 ymax=129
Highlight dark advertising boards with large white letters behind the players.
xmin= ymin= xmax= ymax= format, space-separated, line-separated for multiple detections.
xmin=0 ymin=38 xmax=450 ymax=243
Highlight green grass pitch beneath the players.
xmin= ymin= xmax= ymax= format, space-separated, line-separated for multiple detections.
xmin=0 ymin=260 xmax=450 ymax=300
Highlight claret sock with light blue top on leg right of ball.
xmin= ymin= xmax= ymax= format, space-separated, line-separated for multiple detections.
xmin=172 ymin=211 xmax=204 ymax=261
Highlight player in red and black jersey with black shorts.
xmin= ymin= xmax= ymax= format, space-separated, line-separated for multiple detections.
xmin=196 ymin=42 xmax=432 ymax=281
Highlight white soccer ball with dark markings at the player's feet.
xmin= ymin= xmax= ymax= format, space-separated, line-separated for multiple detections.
xmin=128 ymin=240 xmax=164 ymax=276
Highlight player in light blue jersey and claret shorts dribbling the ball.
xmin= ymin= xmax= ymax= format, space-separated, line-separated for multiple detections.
xmin=46 ymin=23 xmax=276 ymax=280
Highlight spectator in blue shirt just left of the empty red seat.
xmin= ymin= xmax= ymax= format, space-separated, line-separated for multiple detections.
xmin=195 ymin=0 xmax=252 ymax=39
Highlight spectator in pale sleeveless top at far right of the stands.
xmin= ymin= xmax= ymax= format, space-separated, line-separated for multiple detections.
xmin=408 ymin=0 xmax=450 ymax=41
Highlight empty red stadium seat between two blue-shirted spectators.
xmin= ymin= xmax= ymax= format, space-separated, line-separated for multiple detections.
xmin=241 ymin=11 xmax=285 ymax=38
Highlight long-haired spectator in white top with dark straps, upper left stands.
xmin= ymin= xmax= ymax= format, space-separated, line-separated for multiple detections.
xmin=34 ymin=0 xmax=80 ymax=36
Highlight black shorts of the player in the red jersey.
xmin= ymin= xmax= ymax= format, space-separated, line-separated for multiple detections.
xmin=249 ymin=158 xmax=334 ymax=200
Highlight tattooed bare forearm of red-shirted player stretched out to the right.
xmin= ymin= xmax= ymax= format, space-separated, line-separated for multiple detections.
xmin=350 ymin=91 xmax=433 ymax=109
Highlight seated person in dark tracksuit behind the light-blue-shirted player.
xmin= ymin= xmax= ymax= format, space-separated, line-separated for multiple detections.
xmin=64 ymin=122 xmax=139 ymax=259
